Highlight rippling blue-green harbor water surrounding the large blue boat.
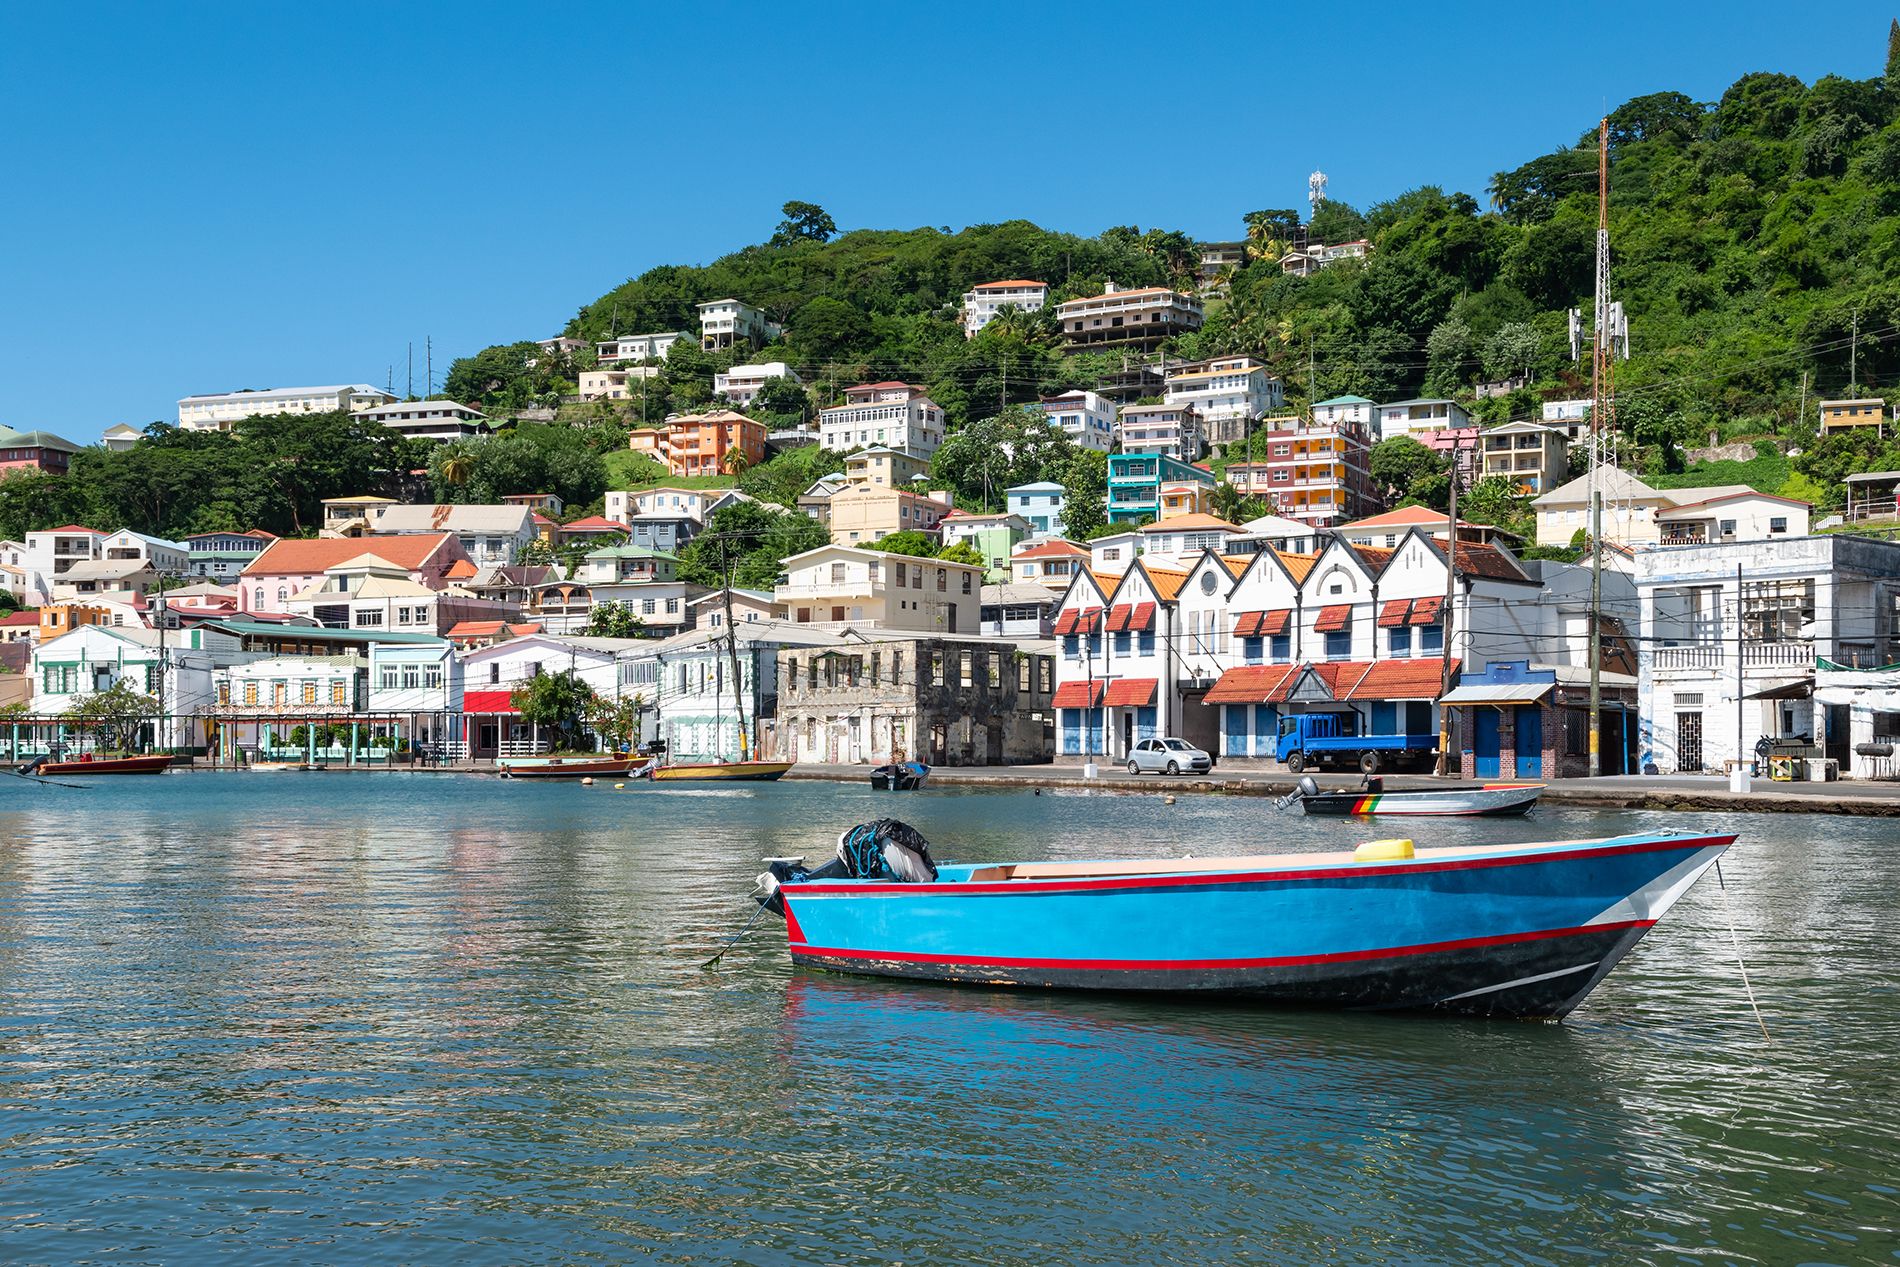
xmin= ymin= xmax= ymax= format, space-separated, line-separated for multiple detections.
xmin=0 ymin=773 xmax=1900 ymax=1263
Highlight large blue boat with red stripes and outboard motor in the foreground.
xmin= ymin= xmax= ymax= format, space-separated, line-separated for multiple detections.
xmin=760 ymin=821 xmax=1735 ymax=1018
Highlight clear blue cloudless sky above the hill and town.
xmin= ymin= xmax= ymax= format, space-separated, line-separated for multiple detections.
xmin=0 ymin=0 xmax=1900 ymax=443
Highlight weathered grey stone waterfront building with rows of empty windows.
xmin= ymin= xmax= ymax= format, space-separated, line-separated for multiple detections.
xmin=779 ymin=636 xmax=1056 ymax=766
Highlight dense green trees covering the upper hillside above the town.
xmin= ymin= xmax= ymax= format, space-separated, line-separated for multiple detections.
xmin=435 ymin=26 xmax=1900 ymax=509
